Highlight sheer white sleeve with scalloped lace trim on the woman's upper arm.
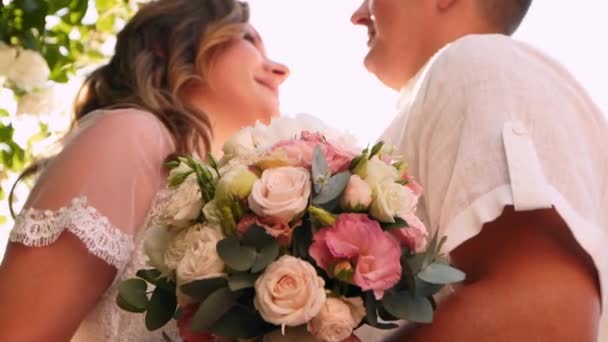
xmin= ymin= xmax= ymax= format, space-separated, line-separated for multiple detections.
xmin=10 ymin=109 xmax=173 ymax=270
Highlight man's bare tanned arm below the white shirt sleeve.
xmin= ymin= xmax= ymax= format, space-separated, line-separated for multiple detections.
xmin=393 ymin=207 xmax=600 ymax=342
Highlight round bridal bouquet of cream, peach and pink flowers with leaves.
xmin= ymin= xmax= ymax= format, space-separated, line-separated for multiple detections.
xmin=117 ymin=118 xmax=464 ymax=342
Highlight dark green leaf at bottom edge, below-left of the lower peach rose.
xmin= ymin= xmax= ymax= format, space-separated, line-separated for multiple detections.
xmin=209 ymin=305 xmax=277 ymax=339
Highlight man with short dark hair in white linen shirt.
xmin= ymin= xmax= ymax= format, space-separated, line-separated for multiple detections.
xmin=352 ymin=0 xmax=608 ymax=342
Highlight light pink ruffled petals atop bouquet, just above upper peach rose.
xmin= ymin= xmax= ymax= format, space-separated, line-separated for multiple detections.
xmin=263 ymin=132 xmax=355 ymax=174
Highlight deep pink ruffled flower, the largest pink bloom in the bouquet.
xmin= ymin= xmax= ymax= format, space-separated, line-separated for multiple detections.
xmin=310 ymin=214 xmax=401 ymax=299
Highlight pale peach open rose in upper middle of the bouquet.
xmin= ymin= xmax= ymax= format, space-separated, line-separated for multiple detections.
xmin=249 ymin=166 xmax=311 ymax=222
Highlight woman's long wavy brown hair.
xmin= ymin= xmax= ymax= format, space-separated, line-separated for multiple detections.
xmin=8 ymin=0 xmax=249 ymax=217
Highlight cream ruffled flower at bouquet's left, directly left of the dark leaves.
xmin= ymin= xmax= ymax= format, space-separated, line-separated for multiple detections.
xmin=177 ymin=227 xmax=225 ymax=285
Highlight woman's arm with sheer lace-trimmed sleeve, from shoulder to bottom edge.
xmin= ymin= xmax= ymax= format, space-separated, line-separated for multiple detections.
xmin=0 ymin=110 xmax=170 ymax=342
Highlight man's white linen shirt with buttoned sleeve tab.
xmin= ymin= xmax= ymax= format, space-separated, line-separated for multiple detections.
xmin=382 ymin=35 xmax=608 ymax=342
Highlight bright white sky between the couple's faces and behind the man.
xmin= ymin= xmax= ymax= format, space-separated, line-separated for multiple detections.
xmin=249 ymin=0 xmax=608 ymax=145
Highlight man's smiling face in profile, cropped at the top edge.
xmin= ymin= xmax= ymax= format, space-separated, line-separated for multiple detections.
xmin=351 ymin=0 xmax=438 ymax=90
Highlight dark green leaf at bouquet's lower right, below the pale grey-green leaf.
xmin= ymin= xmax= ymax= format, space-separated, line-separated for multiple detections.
xmin=382 ymin=291 xmax=433 ymax=323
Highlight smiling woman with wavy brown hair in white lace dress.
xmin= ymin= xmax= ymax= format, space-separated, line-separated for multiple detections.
xmin=0 ymin=0 xmax=289 ymax=342
